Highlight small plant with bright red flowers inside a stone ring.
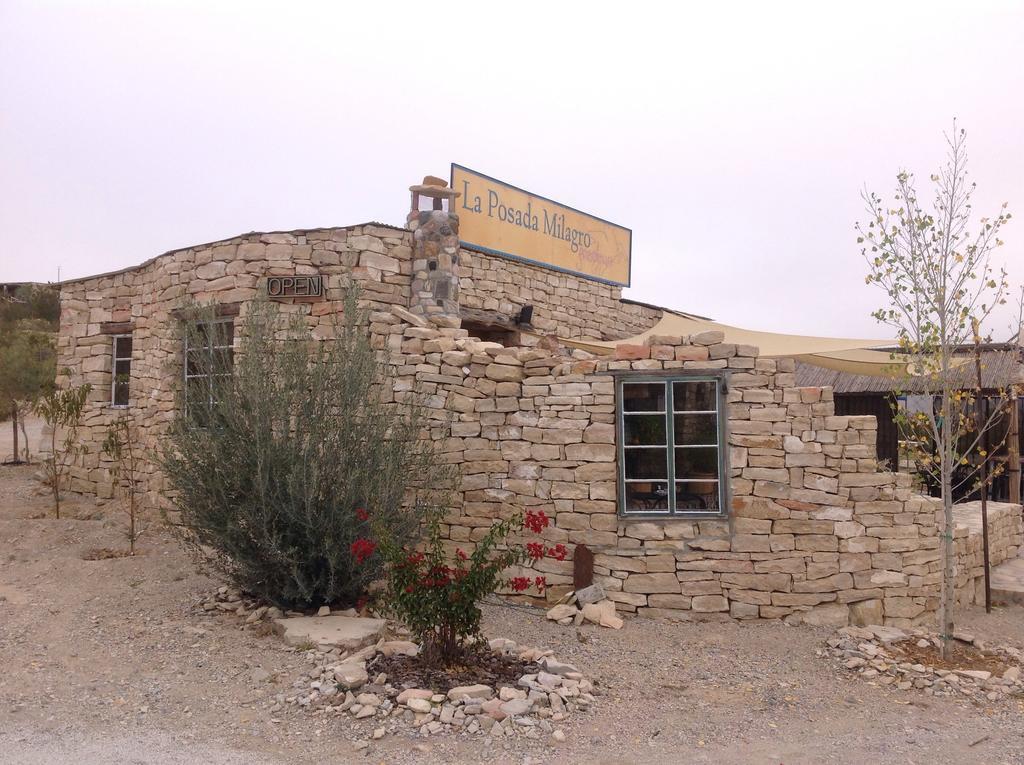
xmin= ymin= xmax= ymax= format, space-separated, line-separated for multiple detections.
xmin=352 ymin=501 xmax=567 ymax=665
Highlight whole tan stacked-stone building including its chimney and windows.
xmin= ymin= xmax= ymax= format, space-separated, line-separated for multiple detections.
xmin=58 ymin=178 xmax=1022 ymax=625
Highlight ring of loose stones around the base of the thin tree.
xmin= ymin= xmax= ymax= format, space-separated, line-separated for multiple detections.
xmin=824 ymin=625 xmax=1024 ymax=702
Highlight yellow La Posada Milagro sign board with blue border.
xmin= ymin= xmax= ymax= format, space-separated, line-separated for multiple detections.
xmin=452 ymin=163 xmax=633 ymax=287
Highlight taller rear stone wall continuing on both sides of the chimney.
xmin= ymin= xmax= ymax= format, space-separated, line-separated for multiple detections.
xmin=57 ymin=224 xmax=660 ymax=496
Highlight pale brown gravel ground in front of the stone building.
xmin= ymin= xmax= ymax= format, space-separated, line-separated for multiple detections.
xmin=0 ymin=467 xmax=1024 ymax=765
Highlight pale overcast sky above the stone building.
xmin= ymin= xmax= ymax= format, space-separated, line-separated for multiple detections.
xmin=0 ymin=0 xmax=1024 ymax=339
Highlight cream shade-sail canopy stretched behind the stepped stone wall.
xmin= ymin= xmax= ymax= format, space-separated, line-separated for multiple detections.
xmin=559 ymin=310 xmax=905 ymax=376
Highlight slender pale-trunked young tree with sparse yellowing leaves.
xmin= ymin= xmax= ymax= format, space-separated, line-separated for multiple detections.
xmin=856 ymin=122 xmax=1011 ymax=655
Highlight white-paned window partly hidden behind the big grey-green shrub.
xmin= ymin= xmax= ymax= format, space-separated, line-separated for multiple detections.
xmin=184 ymin=318 xmax=234 ymax=419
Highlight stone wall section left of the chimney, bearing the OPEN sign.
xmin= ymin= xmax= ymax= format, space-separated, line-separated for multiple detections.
xmin=57 ymin=225 xmax=412 ymax=499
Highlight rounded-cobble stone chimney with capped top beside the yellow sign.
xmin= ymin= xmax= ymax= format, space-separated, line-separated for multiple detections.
xmin=406 ymin=175 xmax=462 ymax=327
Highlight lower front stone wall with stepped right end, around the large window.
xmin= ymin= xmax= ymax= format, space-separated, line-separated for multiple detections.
xmin=381 ymin=316 xmax=1020 ymax=626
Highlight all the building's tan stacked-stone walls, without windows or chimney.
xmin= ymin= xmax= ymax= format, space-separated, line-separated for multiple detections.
xmin=58 ymin=225 xmax=1021 ymax=626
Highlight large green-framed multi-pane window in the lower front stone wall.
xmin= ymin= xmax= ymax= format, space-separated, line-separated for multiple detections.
xmin=617 ymin=376 xmax=728 ymax=516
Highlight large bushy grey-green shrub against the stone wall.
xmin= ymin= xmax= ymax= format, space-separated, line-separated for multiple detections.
xmin=161 ymin=289 xmax=451 ymax=608
